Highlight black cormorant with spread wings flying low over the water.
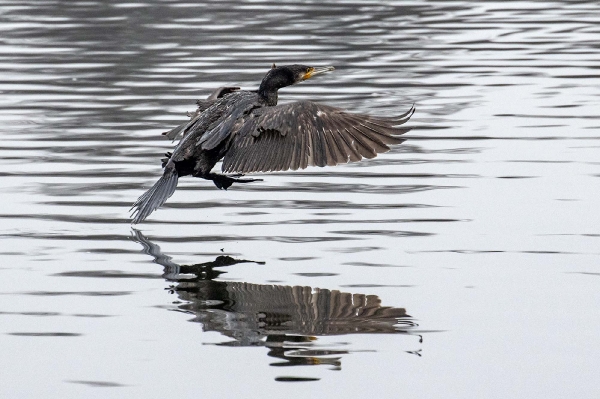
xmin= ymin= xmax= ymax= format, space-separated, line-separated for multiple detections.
xmin=131 ymin=64 xmax=414 ymax=224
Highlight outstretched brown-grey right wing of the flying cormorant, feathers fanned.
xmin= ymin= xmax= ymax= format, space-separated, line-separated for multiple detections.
xmin=222 ymin=101 xmax=414 ymax=173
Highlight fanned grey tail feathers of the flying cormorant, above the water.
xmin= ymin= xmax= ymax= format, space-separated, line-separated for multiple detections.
xmin=130 ymin=162 xmax=179 ymax=224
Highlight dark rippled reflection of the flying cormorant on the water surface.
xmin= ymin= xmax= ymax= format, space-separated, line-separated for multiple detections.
xmin=133 ymin=230 xmax=415 ymax=346
